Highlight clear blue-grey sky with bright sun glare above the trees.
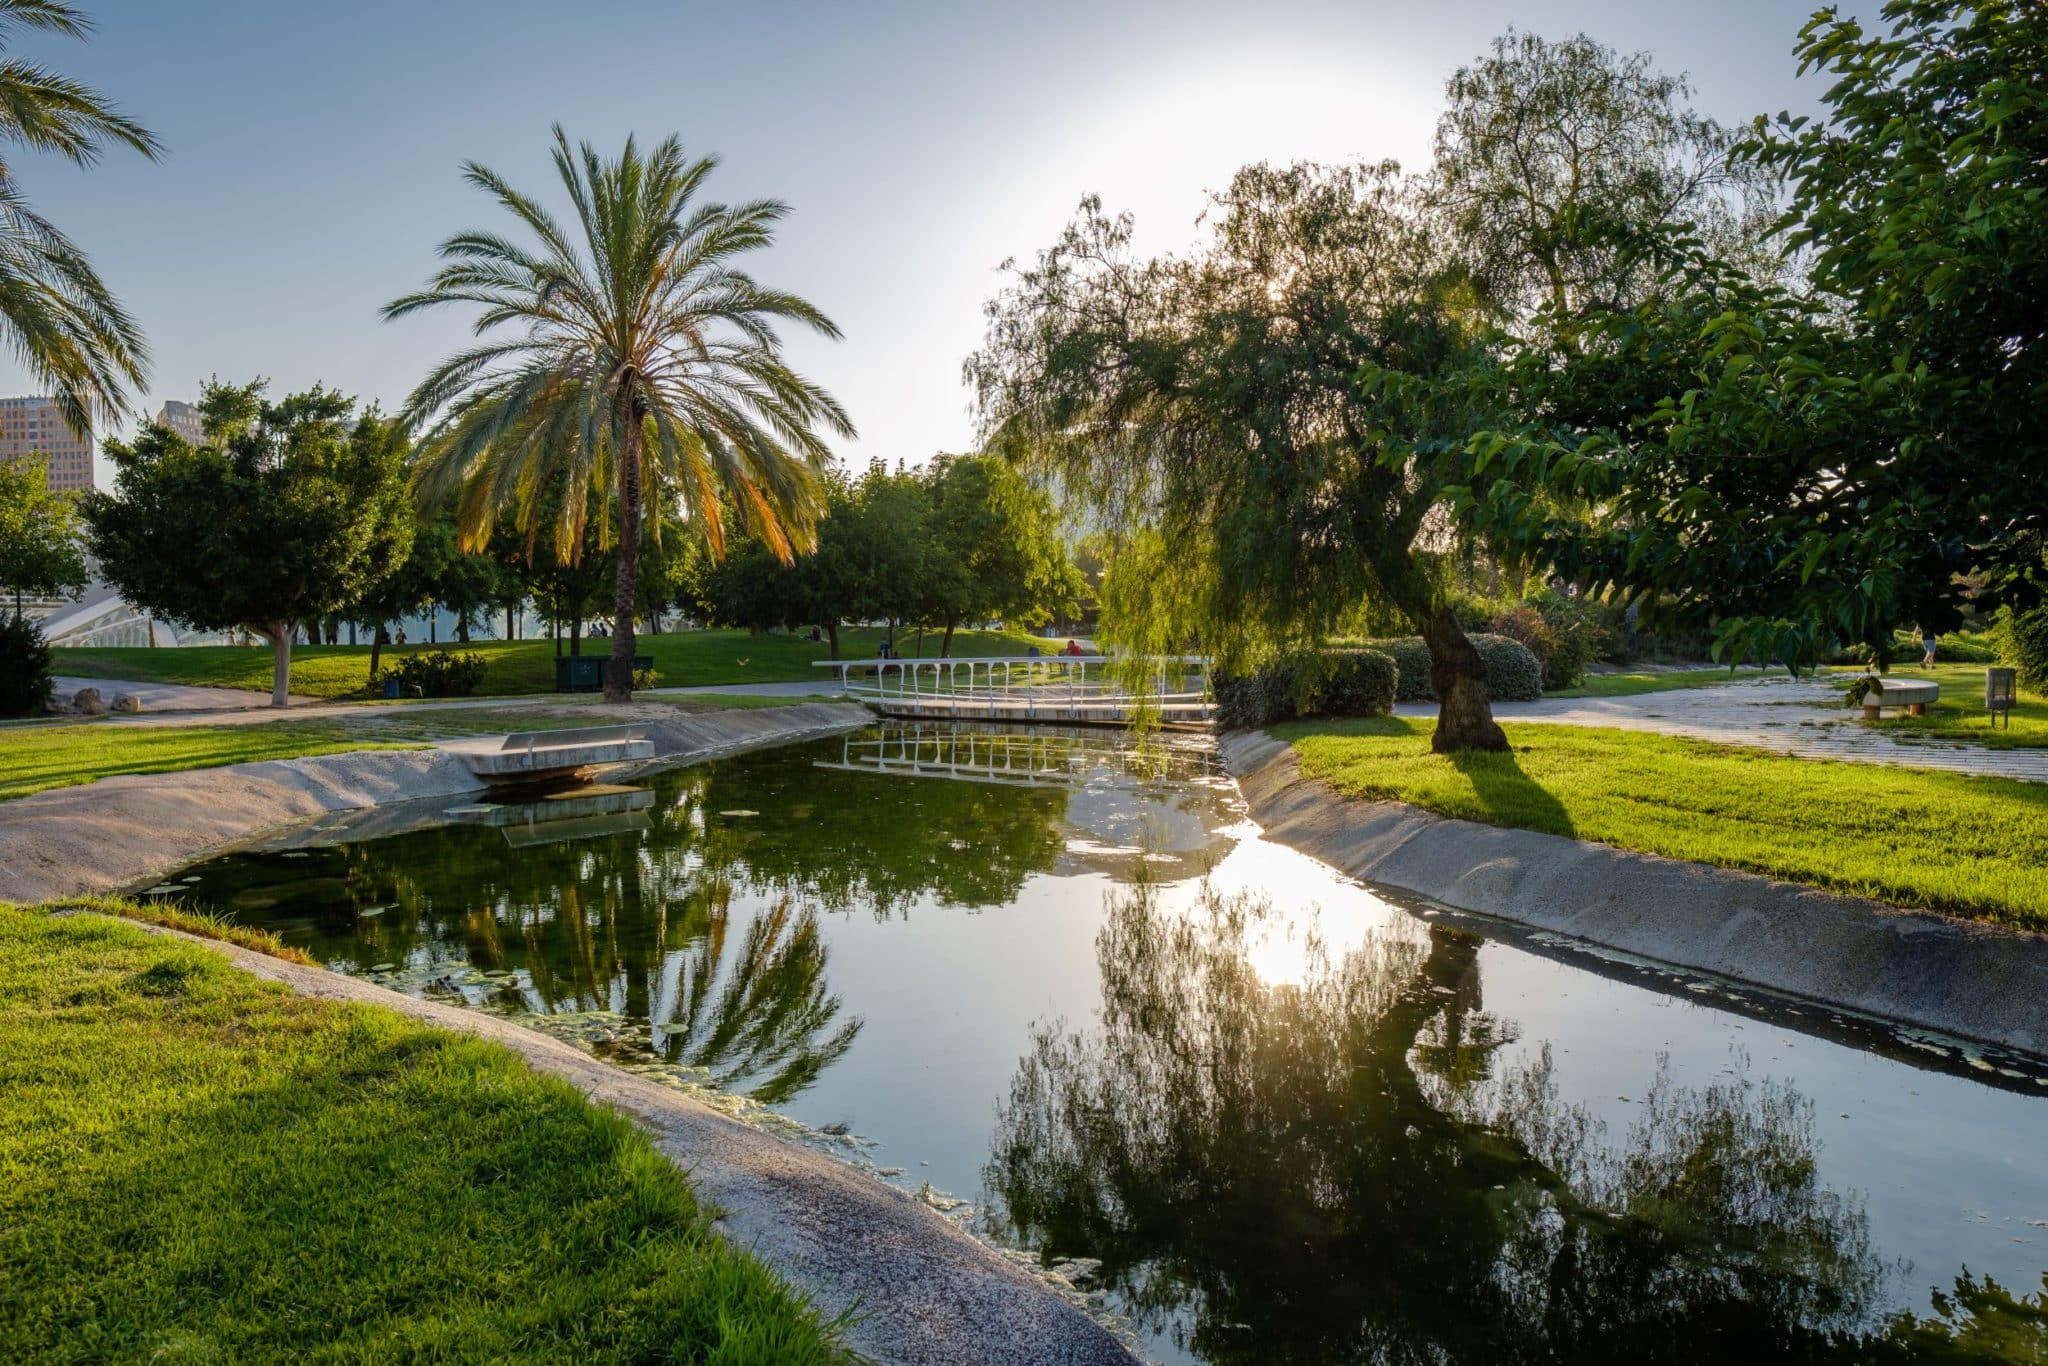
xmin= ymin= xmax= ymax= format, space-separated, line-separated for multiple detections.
xmin=0 ymin=0 xmax=1874 ymax=479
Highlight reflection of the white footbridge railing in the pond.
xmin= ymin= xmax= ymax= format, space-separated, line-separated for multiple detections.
xmin=817 ymin=721 xmax=1223 ymax=788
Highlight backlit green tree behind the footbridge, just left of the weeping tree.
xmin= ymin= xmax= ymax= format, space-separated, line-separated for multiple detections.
xmin=924 ymin=455 xmax=1085 ymax=657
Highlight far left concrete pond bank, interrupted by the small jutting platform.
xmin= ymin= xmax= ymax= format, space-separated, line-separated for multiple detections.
xmin=0 ymin=702 xmax=872 ymax=901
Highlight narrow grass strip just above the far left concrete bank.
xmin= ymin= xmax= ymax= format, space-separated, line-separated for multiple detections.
xmin=0 ymin=694 xmax=815 ymax=801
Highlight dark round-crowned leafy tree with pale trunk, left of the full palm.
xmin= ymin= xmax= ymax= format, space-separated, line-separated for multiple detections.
xmin=84 ymin=379 xmax=414 ymax=707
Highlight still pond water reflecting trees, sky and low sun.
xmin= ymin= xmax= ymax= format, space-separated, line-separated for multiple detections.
xmin=172 ymin=725 xmax=2048 ymax=1362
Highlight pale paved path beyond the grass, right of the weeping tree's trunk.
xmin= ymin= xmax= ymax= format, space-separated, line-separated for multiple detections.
xmin=1395 ymin=678 xmax=2048 ymax=782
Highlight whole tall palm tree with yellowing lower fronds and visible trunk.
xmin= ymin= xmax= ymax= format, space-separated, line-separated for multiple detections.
xmin=385 ymin=125 xmax=854 ymax=702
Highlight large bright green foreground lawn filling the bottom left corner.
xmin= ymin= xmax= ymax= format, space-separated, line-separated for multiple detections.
xmin=0 ymin=907 xmax=838 ymax=1364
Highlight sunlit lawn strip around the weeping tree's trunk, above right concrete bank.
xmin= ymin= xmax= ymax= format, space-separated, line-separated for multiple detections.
xmin=1274 ymin=717 xmax=2048 ymax=930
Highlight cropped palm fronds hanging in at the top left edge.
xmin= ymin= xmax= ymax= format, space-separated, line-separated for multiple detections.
xmin=0 ymin=0 xmax=164 ymax=436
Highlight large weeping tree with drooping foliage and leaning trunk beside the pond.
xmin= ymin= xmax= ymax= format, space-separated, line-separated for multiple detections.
xmin=967 ymin=166 xmax=1507 ymax=752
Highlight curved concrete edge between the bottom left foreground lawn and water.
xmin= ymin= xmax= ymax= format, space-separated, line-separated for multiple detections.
xmin=108 ymin=917 xmax=1133 ymax=1366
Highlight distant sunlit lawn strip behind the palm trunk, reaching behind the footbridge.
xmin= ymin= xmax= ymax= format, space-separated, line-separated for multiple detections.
xmin=51 ymin=627 xmax=1051 ymax=696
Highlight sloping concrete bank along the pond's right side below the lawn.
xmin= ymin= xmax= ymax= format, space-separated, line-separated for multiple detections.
xmin=1221 ymin=733 xmax=2048 ymax=1057
